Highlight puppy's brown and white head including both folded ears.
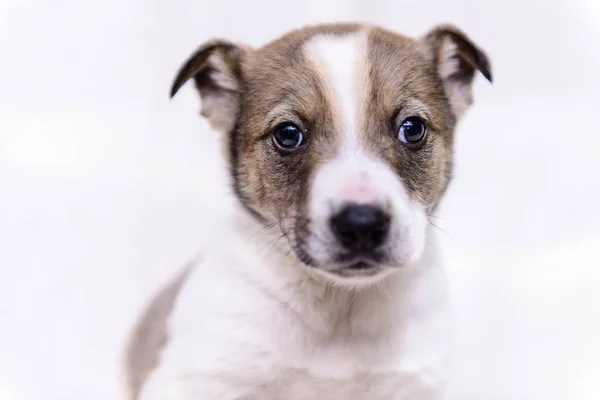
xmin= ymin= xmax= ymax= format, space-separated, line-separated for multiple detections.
xmin=172 ymin=25 xmax=491 ymax=281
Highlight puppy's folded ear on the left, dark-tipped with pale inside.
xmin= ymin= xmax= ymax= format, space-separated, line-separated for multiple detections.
xmin=171 ymin=40 xmax=248 ymax=131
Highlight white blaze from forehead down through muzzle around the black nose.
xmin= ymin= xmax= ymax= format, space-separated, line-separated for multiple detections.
xmin=304 ymin=31 xmax=426 ymax=268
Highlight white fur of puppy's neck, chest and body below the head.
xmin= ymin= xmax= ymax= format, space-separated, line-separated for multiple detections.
xmin=141 ymin=211 xmax=447 ymax=400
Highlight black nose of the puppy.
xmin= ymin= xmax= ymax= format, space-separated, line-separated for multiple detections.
xmin=331 ymin=205 xmax=390 ymax=252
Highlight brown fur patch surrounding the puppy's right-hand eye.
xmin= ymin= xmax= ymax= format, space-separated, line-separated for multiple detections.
xmin=364 ymin=29 xmax=456 ymax=207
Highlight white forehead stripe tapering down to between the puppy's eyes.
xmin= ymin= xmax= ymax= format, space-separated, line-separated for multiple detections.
xmin=305 ymin=31 xmax=368 ymax=150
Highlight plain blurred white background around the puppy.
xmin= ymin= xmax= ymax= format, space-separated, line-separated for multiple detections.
xmin=0 ymin=0 xmax=600 ymax=400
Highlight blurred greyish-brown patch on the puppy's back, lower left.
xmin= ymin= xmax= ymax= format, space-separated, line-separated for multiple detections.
xmin=124 ymin=258 xmax=198 ymax=400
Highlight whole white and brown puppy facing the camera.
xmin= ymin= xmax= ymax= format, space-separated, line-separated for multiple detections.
xmin=127 ymin=24 xmax=491 ymax=400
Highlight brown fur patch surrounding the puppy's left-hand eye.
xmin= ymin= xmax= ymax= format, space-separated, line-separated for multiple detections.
xmin=230 ymin=25 xmax=360 ymax=219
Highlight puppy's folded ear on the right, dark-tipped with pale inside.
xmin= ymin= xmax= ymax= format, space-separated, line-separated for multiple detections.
xmin=422 ymin=25 xmax=492 ymax=118
